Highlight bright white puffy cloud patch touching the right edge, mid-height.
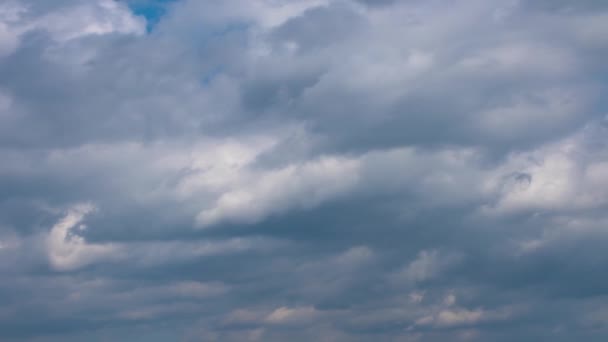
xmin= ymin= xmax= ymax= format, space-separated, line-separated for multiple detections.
xmin=483 ymin=125 xmax=608 ymax=214
